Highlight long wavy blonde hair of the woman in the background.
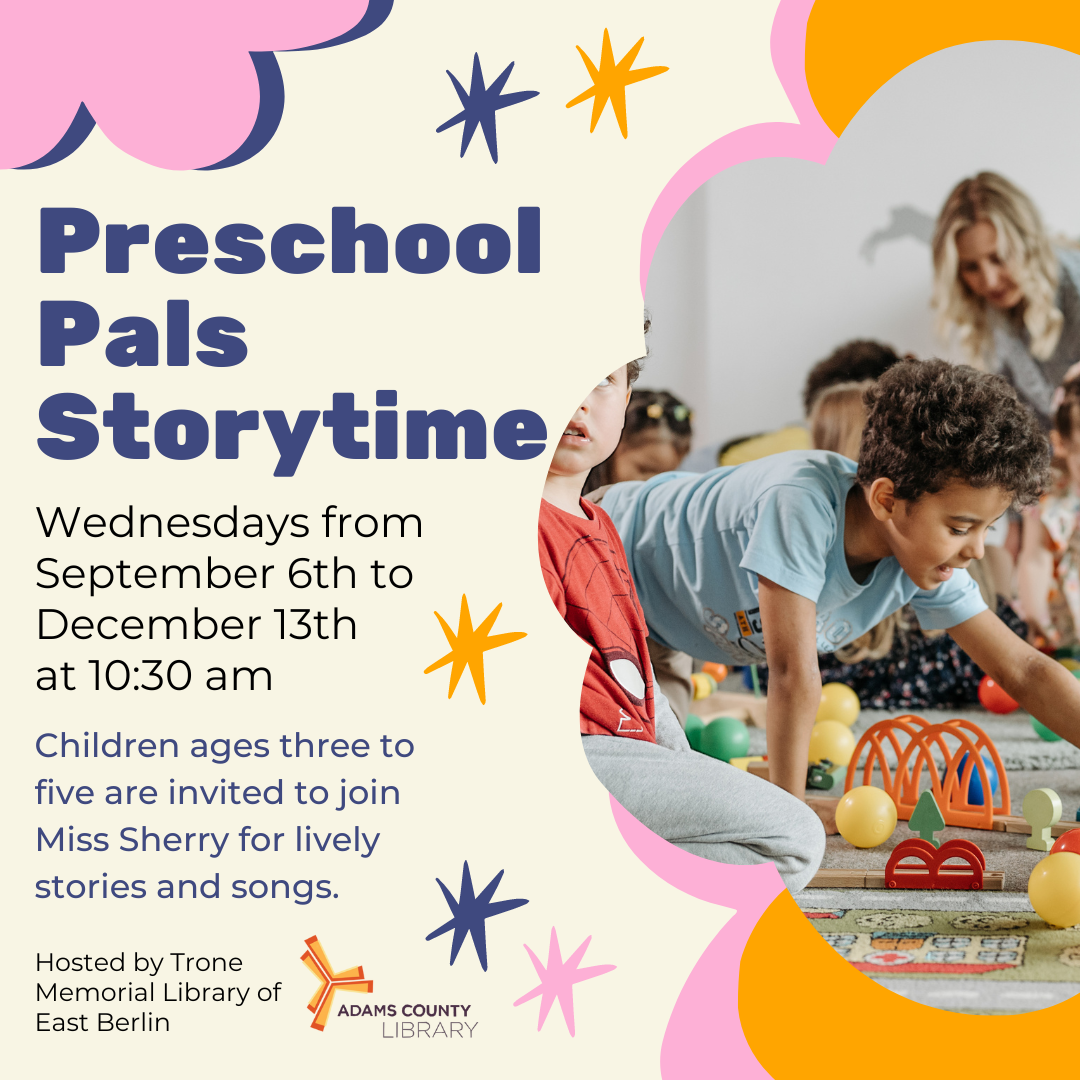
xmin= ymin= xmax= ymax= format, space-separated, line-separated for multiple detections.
xmin=931 ymin=173 xmax=1064 ymax=367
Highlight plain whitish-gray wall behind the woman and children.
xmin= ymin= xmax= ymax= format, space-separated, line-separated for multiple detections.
xmin=640 ymin=42 xmax=1080 ymax=446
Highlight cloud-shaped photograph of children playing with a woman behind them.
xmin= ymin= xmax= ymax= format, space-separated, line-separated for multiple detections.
xmin=540 ymin=42 xmax=1080 ymax=1012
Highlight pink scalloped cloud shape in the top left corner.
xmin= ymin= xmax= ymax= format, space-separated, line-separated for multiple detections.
xmin=0 ymin=0 xmax=368 ymax=170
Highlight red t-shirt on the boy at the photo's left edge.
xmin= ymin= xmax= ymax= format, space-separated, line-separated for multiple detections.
xmin=539 ymin=500 xmax=657 ymax=742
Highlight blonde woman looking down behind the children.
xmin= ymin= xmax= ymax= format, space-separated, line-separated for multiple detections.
xmin=932 ymin=173 xmax=1080 ymax=431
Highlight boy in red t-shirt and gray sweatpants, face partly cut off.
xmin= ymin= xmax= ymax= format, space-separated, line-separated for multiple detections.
xmin=539 ymin=361 xmax=825 ymax=891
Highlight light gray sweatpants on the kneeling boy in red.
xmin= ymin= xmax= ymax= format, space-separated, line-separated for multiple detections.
xmin=581 ymin=691 xmax=825 ymax=892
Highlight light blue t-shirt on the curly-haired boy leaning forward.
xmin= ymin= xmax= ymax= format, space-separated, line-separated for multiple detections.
xmin=602 ymin=450 xmax=986 ymax=664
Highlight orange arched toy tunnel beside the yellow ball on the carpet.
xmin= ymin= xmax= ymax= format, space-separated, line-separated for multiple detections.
xmin=843 ymin=716 xmax=1012 ymax=828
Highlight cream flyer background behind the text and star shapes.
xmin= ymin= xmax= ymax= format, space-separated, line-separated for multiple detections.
xmin=0 ymin=0 xmax=794 ymax=1078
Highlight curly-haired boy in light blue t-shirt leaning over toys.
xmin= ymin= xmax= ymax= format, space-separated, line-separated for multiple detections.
xmin=602 ymin=361 xmax=1080 ymax=795
